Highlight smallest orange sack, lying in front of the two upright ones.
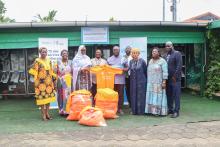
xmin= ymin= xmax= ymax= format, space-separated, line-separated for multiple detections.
xmin=79 ymin=106 xmax=107 ymax=127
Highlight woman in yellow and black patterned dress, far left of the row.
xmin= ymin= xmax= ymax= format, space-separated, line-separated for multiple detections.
xmin=29 ymin=47 xmax=56 ymax=121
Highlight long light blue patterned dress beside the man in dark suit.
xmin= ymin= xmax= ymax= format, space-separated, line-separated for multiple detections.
xmin=145 ymin=58 xmax=168 ymax=115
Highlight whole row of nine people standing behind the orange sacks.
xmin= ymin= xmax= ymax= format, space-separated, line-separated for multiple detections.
xmin=29 ymin=41 xmax=182 ymax=120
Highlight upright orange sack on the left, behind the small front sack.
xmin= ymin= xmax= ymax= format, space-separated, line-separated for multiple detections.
xmin=66 ymin=90 xmax=92 ymax=120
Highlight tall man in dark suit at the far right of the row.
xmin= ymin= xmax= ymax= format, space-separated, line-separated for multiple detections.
xmin=165 ymin=41 xmax=182 ymax=118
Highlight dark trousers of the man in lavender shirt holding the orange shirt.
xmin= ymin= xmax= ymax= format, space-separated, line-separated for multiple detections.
xmin=114 ymin=84 xmax=124 ymax=110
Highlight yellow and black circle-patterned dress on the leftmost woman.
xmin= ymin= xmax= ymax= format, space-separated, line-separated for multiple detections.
xmin=29 ymin=58 xmax=56 ymax=105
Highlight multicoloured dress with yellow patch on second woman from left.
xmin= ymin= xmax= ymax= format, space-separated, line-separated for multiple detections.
xmin=56 ymin=60 xmax=72 ymax=114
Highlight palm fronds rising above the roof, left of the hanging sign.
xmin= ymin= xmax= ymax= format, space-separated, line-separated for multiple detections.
xmin=35 ymin=10 xmax=57 ymax=22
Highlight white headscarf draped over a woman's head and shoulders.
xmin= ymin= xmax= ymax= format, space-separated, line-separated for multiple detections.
xmin=72 ymin=45 xmax=92 ymax=68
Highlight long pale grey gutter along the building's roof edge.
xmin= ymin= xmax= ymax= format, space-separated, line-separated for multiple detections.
xmin=0 ymin=21 xmax=208 ymax=28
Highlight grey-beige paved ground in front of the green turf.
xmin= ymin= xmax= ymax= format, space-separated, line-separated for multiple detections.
xmin=0 ymin=121 xmax=220 ymax=147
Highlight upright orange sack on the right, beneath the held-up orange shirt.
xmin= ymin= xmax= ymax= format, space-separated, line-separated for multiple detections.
xmin=95 ymin=88 xmax=118 ymax=118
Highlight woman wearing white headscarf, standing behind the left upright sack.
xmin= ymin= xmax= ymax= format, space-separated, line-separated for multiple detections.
xmin=72 ymin=45 xmax=92 ymax=91
